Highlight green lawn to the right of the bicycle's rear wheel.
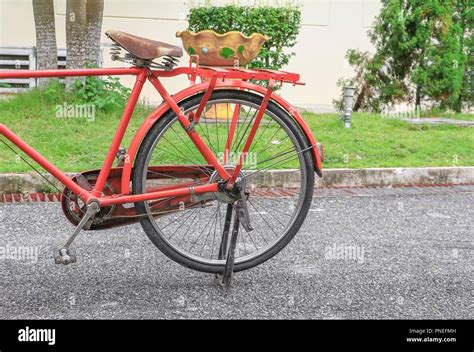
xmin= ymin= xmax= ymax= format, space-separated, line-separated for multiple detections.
xmin=304 ymin=113 xmax=474 ymax=168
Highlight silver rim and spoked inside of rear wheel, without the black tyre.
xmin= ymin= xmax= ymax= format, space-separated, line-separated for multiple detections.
xmin=138 ymin=99 xmax=309 ymax=265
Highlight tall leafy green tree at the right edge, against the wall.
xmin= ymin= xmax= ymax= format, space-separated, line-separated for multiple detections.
xmin=339 ymin=0 xmax=474 ymax=112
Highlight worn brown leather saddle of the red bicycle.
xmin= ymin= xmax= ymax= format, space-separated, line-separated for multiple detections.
xmin=105 ymin=30 xmax=183 ymax=60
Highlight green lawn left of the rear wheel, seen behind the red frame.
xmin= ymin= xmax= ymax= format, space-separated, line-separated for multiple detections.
xmin=0 ymin=91 xmax=149 ymax=172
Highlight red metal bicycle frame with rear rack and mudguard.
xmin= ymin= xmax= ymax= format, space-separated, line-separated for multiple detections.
xmin=0 ymin=63 xmax=322 ymax=206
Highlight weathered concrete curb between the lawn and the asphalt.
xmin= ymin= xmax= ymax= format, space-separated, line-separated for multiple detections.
xmin=0 ymin=167 xmax=474 ymax=194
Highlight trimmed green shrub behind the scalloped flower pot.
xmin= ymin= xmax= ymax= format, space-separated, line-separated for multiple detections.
xmin=188 ymin=5 xmax=301 ymax=70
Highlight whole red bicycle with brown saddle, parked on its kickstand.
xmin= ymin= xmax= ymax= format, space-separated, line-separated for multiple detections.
xmin=0 ymin=31 xmax=323 ymax=285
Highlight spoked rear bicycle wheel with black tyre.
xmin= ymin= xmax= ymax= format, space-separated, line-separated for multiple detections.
xmin=133 ymin=90 xmax=314 ymax=273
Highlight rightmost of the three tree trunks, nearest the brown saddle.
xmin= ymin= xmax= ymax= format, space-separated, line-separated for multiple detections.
xmin=85 ymin=0 xmax=104 ymax=67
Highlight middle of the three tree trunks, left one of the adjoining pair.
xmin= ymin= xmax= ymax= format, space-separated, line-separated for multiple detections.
xmin=66 ymin=0 xmax=87 ymax=89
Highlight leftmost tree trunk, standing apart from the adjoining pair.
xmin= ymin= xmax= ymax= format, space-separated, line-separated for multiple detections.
xmin=32 ymin=0 xmax=58 ymax=88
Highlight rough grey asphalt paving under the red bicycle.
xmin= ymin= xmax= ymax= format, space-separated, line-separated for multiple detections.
xmin=0 ymin=186 xmax=474 ymax=319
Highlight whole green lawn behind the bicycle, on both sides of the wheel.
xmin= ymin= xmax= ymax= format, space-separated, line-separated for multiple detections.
xmin=0 ymin=91 xmax=474 ymax=173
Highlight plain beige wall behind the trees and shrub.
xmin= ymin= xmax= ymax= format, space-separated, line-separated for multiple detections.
xmin=0 ymin=0 xmax=380 ymax=110
